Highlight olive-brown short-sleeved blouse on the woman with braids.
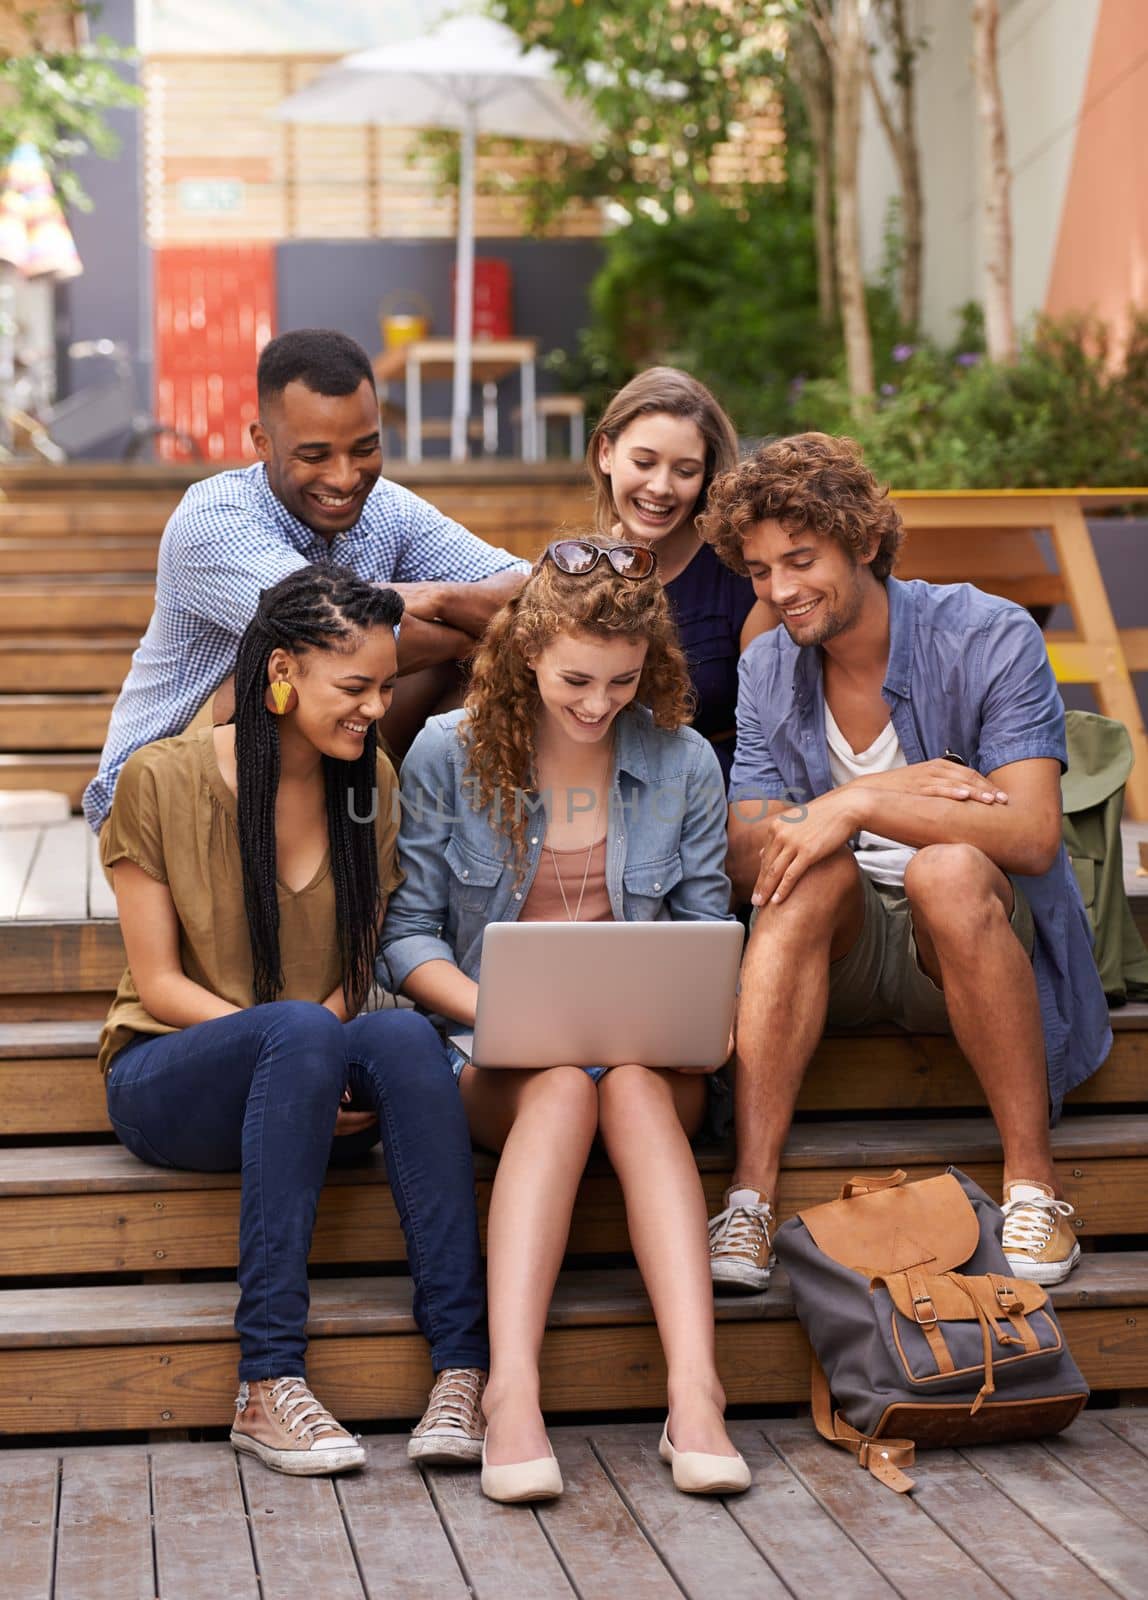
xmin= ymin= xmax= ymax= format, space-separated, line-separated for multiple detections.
xmin=99 ymin=728 xmax=403 ymax=1072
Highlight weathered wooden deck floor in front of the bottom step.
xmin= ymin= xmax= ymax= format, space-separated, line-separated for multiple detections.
xmin=0 ymin=1411 xmax=1148 ymax=1600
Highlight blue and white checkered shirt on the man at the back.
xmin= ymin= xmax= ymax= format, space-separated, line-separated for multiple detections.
xmin=83 ymin=464 xmax=528 ymax=830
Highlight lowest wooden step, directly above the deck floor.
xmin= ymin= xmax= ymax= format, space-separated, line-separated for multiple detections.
xmin=0 ymin=1253 xmax=1148 ymax=1434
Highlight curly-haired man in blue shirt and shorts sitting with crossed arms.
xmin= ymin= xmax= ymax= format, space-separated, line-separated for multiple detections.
xmin=704 ymin=434 xmax=1111 ymax=1290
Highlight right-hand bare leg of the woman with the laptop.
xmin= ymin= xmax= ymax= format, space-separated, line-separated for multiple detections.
xmin=598 ymin=1067 xmax=737 ymax=1456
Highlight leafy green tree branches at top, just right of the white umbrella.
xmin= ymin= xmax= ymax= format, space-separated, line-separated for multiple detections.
xmin=488 ymin=0 xmax=793 ymax=230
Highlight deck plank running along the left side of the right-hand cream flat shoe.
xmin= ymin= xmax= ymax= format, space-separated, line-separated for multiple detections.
xmin=592 ymin=1424 xmax=788 ymax=1600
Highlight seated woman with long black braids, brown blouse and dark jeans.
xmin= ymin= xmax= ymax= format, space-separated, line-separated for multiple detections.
xmin=99 ymin=566 xmax=488 ymax=1475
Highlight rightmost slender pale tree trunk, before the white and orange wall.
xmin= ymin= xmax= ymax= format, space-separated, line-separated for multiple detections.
xmin=972 ymin=0 xmax=1017 ymax=362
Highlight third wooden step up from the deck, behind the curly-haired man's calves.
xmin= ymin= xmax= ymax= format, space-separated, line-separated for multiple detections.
xmin=8 ymin=1004 xmax=1148 ymax=1138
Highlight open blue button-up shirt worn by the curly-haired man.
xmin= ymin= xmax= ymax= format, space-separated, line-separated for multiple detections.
xmin=729 ymin=578 xmax=1113 ymax=1115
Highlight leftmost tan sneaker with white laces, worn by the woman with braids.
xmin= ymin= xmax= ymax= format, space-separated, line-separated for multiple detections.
xmin=232 ymin=1378 xmax=366 ymax=1478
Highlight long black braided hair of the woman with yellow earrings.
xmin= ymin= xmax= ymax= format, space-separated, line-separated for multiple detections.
xmin=235 ymin=566 xmax=403 ymax=1016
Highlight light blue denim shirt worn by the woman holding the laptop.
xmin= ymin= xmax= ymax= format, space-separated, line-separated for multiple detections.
xmin=381 ymin=706 xmax=729 ymax=987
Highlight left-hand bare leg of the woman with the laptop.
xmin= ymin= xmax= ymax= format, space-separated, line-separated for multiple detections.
xmin=460 ymin=1067 xmax=601 ymax=1466
